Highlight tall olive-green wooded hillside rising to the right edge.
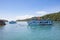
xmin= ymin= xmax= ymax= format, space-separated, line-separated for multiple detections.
xmin=42 ymin=12 xmax=60 ymax=21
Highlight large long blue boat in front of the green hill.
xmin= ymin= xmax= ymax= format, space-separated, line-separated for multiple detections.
xmin=27 ymin=19 xmax=53 ymax=25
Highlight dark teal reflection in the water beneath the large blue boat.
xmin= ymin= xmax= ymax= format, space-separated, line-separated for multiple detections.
xmin=27 ymin=25 xmax=53 ymax=31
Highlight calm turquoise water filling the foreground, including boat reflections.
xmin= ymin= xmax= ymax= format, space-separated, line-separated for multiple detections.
xmin=0 ymin=22 xmax=60 ymax=40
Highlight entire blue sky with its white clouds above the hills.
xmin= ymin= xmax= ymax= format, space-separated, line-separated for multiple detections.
xmin=0 ymin=0 xmax=60 ymax=20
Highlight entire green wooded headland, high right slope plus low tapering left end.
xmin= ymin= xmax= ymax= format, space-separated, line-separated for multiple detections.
xmin=16 ymin=12 xmax=60 ymax=21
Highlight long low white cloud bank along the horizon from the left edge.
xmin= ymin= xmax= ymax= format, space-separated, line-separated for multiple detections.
xmin=0 ymin=15 xmax=33 ymax=21
